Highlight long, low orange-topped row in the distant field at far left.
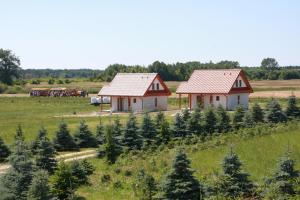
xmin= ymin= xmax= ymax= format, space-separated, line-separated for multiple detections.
xmin=30 ymin=88 xmax=88 ymax=97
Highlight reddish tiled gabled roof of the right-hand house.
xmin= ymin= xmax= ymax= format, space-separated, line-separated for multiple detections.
xmin=176 ymin=69 xmax=252 ymax=94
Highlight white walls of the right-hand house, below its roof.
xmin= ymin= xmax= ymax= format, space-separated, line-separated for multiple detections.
xmin=191 ymin=93 xmax=249 ymax=110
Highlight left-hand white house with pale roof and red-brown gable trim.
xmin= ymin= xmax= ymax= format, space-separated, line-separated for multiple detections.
xmin=98 ymin=73 xmax=171 ymax=112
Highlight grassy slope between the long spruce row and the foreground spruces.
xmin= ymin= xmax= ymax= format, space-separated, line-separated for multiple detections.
xmin=78 ymin=123 xmax=300 ymax=200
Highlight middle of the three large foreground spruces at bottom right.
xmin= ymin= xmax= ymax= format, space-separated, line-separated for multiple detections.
xmin=217 ymin=150 xmax=254 ymax=198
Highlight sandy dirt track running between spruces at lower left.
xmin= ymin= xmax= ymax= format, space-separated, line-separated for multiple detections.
xmin=0 ymin=150 xmax=97 ymax=174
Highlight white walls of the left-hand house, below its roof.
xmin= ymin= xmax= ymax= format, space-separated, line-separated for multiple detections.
xmin=111 ymin=96 xmax=168 ymax=112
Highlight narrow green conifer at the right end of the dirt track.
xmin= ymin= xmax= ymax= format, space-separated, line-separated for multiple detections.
xmin=104 ymin=125 xmax=121 ymax=164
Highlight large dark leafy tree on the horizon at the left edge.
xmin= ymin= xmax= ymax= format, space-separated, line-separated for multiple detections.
xmin=0 ymin=49 xmax=20 ymax=85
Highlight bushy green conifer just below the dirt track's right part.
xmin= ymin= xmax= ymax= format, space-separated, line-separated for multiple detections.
xmin=71 ymin=160 xmax=95 ymax=185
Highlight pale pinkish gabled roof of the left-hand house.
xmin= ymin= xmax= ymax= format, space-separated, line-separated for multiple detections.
xmin=98 ymin=73 xmax=169 ymax=96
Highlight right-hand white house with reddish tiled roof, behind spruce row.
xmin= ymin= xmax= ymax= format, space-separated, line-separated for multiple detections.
xmin=176 ymin=69 xmax=253 ymax=110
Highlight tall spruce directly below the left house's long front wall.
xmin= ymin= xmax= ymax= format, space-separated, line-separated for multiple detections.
xmin=123 ymin=113 xmax=143 ymax=150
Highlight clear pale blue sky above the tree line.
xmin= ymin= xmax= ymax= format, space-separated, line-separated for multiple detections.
xmin=0 ymin=0 xmax=300 ymax=69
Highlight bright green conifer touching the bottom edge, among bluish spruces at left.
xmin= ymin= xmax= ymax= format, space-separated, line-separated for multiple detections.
xmin=51 ymin=162 xmax=78 ymax=200
